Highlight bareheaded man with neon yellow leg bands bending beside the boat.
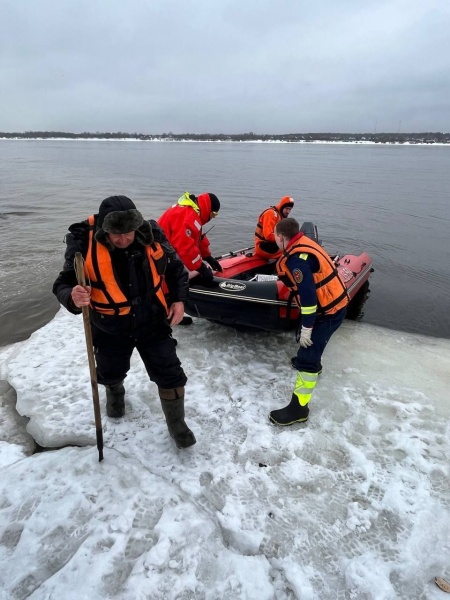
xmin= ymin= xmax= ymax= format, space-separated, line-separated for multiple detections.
xmin=269 ymin=218 xmax=348 ymax=425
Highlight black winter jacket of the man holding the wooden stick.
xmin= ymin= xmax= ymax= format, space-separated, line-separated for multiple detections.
xmin=53 ymin=220 xmax=189 ymax=341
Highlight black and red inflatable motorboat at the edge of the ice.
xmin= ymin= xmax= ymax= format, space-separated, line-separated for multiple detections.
xmin=185 ymin=222 xmax=373 ymax=331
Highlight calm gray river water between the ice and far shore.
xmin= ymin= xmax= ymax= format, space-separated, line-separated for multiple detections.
xmin=0 ymin=140 xmax=450 ymax=345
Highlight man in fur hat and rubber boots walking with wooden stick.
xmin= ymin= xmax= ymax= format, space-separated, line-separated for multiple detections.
xmin=53 ymin=196 xmax=196 ymax=448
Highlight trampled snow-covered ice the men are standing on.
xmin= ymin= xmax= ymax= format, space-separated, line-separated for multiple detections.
xmin=0 ymin=309 xmax=450 ymax=600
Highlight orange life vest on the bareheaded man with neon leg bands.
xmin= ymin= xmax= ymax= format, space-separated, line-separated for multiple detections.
xmin=277 ymin=234 xmax=349 ymax=315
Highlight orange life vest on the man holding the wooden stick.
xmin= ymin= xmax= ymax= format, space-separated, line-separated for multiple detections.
xmin=84 ymin=215 xmax=168 ymax=315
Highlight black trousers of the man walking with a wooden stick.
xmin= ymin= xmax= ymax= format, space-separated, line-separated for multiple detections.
xmin=92 ymin=328 xmax=187 ymax=389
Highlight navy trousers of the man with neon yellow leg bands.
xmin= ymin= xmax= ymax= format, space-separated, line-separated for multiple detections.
xmin=295 ymin=307 xmax=347 ymax=373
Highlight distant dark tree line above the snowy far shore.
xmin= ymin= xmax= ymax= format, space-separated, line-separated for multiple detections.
xmin=0 ymin=131 xmax=450 ymax=144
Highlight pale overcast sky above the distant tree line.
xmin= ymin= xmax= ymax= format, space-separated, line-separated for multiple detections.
xmin=0 ymin=0 xmax=450 ymax=133
